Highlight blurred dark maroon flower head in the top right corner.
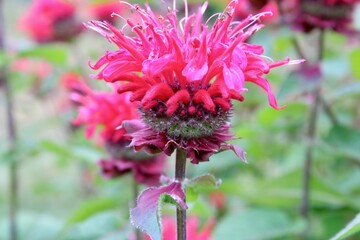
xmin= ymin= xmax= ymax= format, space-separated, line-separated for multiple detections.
xmin=293 ymin=0 xmax=358 ymax=33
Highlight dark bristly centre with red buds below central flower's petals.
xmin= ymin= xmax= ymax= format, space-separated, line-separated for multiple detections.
xmin=140 ymin=86 xmax=230 ymax=139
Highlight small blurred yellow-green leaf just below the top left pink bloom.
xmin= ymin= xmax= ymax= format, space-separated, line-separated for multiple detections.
xmin=18 ymin=44 xmax=68 ymax=65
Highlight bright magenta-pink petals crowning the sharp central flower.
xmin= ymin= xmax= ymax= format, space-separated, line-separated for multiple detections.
xmin=86 ymin=1 xmax=300 ymax=109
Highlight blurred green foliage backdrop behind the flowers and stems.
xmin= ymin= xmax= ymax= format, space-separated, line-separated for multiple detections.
xmin=0 ymin=0 xmax=360 ymax=240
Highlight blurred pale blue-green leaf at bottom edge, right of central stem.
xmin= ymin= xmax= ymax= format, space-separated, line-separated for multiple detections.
xmin=213 ymin=208 xmax=305 ymax=240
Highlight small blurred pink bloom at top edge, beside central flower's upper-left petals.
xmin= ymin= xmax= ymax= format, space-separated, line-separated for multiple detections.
xmin=88 ymin=1 xmax=123 ymax=24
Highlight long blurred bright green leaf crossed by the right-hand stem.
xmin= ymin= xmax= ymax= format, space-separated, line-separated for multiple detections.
xmin=220 ymin=169 xmax=360 ymax=209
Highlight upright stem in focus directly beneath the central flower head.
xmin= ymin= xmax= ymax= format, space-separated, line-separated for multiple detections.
xmin=175 ymin=148 xmax=186 ymax=240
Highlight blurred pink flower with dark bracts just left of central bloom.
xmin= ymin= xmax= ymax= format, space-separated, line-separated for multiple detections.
xmin=65 ymin=75 xmax=165 ymax=185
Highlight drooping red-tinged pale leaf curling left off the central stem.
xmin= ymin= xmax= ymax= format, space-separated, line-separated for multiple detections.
xmin=130 ymin=182 xmax=187 ymax=240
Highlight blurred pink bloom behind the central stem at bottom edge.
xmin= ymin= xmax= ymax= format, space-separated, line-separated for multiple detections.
xmin=146 ymin=217 xmax=214 ymax=240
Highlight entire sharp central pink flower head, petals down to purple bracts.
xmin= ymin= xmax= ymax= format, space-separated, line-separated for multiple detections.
xmin=86 ymin=1 xmax=302 ymax=163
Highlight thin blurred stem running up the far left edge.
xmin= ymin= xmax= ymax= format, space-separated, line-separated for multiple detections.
xmin=0 ymin=0 xmax=18 ymax=240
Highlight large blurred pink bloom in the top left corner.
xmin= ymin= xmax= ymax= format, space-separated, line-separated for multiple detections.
xmin=19 ymin=0 xmax=81 ymax=42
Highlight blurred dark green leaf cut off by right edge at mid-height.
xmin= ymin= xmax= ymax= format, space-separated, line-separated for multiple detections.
xmin=326 ymin=126 xmax=360 ymax=160
